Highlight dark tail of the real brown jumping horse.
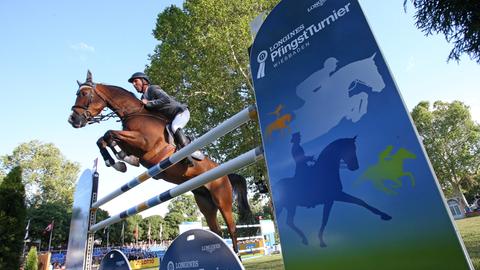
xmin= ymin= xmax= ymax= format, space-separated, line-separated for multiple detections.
xmin=228 ymin=173 xmax=253 ymax=224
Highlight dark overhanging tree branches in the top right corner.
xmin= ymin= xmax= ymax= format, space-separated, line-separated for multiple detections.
xmin=404 ymin=0 xmax=480 ymax=63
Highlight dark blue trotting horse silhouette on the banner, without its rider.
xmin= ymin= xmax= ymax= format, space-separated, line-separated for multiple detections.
xmin=272 ymin=136 xmax=392 ymax=247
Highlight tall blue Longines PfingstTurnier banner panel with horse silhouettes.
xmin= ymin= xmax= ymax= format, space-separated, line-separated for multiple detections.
xmin=250 ymin=0 xmax=471 ymax=269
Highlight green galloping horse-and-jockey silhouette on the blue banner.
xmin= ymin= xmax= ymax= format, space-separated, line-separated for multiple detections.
xmin=357 ymin=145 xmax=417 ymax=195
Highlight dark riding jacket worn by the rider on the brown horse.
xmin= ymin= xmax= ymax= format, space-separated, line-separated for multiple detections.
xmin=142 ymin=85 xmax=188 ymax=121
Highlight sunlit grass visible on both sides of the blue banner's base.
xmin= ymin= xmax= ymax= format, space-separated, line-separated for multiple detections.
xmin=243 ymin=216 xmax=480 ymax=270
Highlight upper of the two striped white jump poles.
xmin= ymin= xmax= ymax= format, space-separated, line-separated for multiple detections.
xmin=92 ymin=105 xmax=257 ymax=209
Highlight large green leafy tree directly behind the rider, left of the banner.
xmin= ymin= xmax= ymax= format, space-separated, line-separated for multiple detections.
xmin=146 ymin=0 xmax=279 ymax=198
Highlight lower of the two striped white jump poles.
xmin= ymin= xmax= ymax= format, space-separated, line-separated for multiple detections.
xmin=89 ymin=147 xmax=263 ymax=233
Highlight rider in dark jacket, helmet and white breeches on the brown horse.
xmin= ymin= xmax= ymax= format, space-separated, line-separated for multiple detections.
xmin=128 ymin=72 xmax=201 ymax=162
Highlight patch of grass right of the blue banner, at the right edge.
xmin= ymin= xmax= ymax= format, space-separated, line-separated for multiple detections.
xmin=456 ymin=216 xmax=480 ymax=270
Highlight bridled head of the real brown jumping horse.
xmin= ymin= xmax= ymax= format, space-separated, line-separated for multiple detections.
xmin=68 ymin=71 xmax=107 ymax=128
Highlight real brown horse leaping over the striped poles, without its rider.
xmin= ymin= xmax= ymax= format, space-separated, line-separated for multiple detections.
xmin=68 ymin=71 xmax=255 ymax=253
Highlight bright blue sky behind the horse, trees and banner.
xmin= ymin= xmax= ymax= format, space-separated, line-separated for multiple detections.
xmin=0 ymin=0 xmax=480 ymax=216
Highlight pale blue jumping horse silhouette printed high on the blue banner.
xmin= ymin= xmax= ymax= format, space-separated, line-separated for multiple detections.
xmin=293 ymin=53 xmax=385 ymax=141
